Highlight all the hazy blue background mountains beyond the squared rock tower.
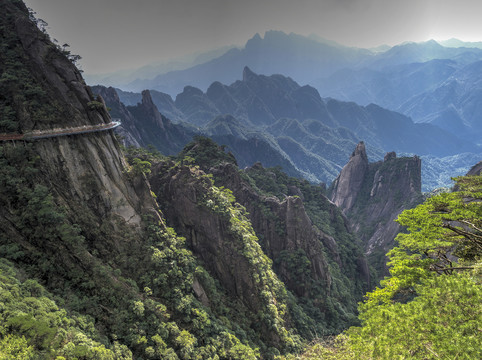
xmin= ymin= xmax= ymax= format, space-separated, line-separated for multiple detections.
xmin=86 ymin=31 xmax=482 ymax=190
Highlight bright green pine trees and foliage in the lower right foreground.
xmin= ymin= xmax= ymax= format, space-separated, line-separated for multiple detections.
xmin=282 ymin=176 xmax=482 ymax=360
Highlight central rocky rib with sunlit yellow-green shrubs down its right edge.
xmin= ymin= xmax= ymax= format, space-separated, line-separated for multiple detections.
xmin=150 ymin=161 xmax=292 ymax=347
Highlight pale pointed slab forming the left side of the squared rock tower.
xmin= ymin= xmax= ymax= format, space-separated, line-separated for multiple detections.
xmin=331 ymin=141 xmax=368 ymax=213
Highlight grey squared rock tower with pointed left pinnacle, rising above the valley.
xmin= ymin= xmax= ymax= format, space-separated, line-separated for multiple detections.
xmin=331 ymin=143 xmax=422 ymax=271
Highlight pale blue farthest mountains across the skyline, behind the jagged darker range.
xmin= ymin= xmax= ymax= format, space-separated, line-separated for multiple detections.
xmin=91 ymin=31 xmax=482 ymax=150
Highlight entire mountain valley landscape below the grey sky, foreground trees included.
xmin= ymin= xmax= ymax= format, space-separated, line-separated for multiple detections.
xmin=0 ymin=0 xmax=482 ymax=360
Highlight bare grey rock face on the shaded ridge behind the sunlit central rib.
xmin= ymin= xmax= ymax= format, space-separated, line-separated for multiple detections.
xmin=211 ymin=164 xmax=340 ymax=297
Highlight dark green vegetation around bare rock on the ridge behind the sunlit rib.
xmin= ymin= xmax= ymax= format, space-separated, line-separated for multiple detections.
xmin=178 ymin=137 xmax=369 ymax=338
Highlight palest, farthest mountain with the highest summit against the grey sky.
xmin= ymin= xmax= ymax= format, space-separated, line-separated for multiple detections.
xmin=128 ymin=31 xmax=371 ymax=96
